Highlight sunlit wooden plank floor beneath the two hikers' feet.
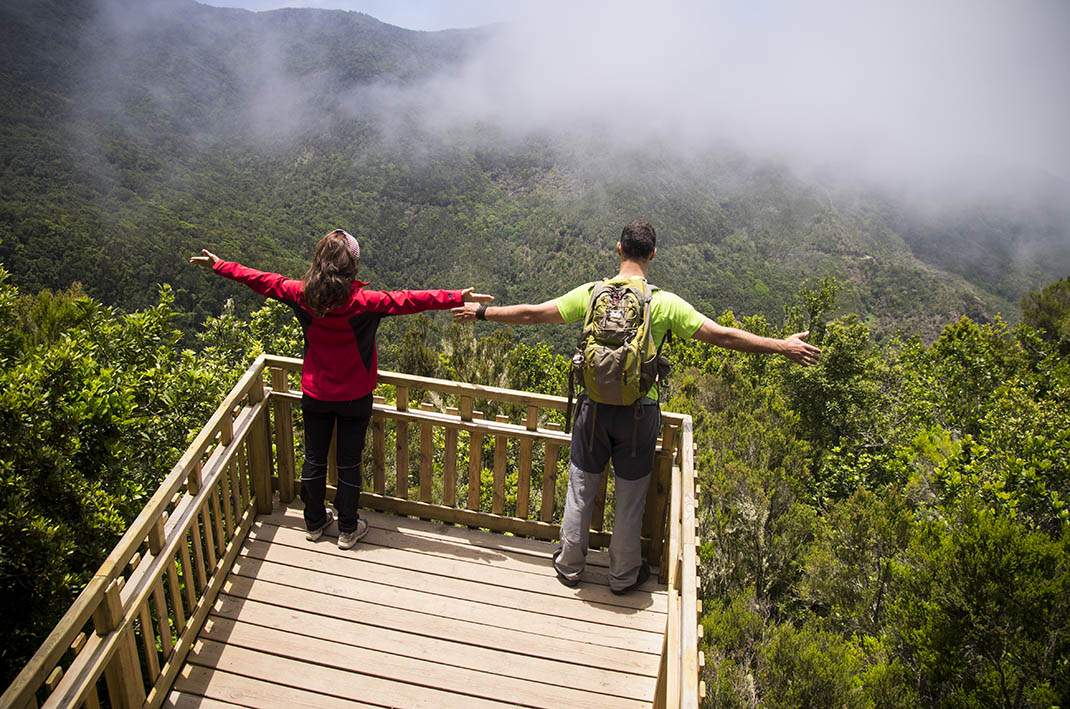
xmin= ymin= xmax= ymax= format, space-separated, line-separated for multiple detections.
xmin=167 ymin=503 xmax=666 ymax=709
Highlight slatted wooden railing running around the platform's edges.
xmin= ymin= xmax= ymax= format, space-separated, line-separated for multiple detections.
xmin=0 ymin=356 xmax=700 ymax=709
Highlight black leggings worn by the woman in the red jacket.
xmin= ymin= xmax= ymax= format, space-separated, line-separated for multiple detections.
xmin=301 ymin=394 xmax=371 ymax=531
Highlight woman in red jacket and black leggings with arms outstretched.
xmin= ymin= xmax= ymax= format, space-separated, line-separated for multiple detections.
xmin=189 ymin=229 xmax=493 ymax=549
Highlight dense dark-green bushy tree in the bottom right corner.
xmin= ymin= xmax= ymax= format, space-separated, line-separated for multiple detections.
xmin=890 ymin=498 xmax=1070 ymax=709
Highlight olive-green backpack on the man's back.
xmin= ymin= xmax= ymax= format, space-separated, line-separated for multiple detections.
xmin=565 ymin=276 xmax=669 ymax=432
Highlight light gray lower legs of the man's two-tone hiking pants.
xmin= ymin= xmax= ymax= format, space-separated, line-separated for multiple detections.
xmin=555 ymin=463 xmax=651 ymax=590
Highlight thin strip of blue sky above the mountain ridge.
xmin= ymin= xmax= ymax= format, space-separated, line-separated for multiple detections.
xmin=198 ymin=0 xmax=533 ymax=30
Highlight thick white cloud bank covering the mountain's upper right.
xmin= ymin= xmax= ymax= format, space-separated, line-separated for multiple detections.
xmin=352 ymin=0 xmax=1070 ymax=204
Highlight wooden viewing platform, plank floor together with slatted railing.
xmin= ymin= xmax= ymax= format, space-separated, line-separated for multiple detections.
xmin=0 ymin=356 xmax=702 ymax=709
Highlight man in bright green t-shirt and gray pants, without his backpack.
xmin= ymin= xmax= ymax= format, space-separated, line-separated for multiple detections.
xmin=453 ymin=220 xmax=821 ymax=595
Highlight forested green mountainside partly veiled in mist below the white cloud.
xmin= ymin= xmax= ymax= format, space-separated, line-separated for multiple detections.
xmin=0 ymin=0 xmax=1068 ymax=346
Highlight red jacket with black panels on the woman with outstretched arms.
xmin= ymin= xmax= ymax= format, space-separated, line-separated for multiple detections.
xmin=212 ymin=260 xmax=461 ymax=401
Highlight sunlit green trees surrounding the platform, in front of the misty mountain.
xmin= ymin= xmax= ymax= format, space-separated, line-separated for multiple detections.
xmin=0 ymin=272 xmax=1070 ymax=707
